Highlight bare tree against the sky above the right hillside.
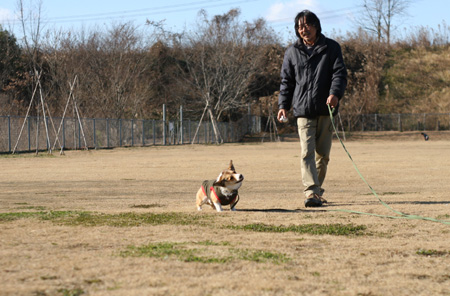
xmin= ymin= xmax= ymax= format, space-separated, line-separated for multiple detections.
xmin=358 ymin=0 xmax=411 ymax=45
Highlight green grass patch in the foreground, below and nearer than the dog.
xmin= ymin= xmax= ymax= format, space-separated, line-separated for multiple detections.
xmin=119 ymin=241 xmax=291 ymax=264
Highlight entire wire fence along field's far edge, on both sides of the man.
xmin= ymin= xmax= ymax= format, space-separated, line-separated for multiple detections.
xmin=0 ymin=113 xmax=450 ymax=153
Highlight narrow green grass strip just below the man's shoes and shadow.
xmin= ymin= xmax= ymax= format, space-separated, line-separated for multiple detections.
xmin=227 ymin=223 xmax=367 ymax=236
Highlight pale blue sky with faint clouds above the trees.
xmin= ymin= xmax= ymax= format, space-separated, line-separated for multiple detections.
xmin=0 ymin=0 xmax=450 ymax=39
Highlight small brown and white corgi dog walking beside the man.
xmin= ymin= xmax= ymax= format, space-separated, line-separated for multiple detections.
xmin=196 ymin=160 xmax=244 ymax=212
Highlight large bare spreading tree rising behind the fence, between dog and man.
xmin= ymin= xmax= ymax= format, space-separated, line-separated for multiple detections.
xmin=176 ymin=9 xmax=274 ymax=143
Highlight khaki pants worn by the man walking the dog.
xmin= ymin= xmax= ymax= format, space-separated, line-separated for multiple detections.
xmin=297 ymin=116 xmax=333 ymax=197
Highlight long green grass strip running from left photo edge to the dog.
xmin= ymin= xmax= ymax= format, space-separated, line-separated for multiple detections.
xmin=0 ymin=211 xmax=211 ymax=227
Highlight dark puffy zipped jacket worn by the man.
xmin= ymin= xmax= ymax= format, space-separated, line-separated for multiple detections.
xmin=278 ymin=34 xmax=347 ymax=118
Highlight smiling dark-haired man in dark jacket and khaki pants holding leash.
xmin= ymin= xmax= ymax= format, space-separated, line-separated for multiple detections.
xmin=277 ymin=10 xmax=347 ymax=207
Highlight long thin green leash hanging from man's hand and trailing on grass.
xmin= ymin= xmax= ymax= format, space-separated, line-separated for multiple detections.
xmin=327 ymin=105 xmax=450 ymax=225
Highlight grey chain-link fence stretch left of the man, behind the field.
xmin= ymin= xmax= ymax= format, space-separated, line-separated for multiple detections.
xmin=0 ymin=115 xmax=261 ymax=153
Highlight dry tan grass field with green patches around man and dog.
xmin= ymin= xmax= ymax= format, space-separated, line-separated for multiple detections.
xmin=0 ymin=133 xmax=450 ymax=296
